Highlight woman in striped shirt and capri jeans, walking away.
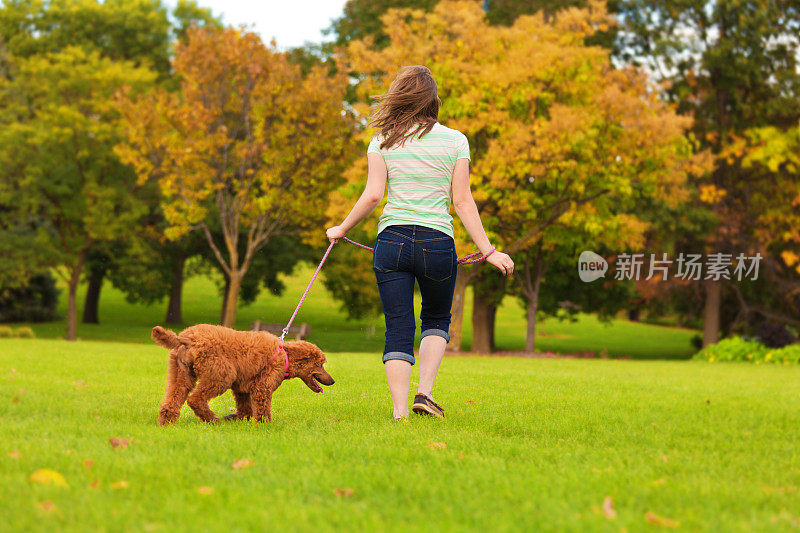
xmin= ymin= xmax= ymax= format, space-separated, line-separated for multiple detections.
xmin=327 ymin=65 xmax=514 ymax=420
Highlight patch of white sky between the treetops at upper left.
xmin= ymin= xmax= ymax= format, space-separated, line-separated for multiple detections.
xmin=182 ymin=0 xmax=345 ymax=49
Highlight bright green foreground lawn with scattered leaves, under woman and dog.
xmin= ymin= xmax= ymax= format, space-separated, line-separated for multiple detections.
xmin=0 ymin=339 xmax=800 ymax=532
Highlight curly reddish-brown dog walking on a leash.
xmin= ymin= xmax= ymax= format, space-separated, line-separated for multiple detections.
xmin=151 ymin=324 xmax=334 ymax=426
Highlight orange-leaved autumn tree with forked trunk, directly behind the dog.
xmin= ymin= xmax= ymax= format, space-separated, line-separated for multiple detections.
xmin=118 ymin=29 xmax=350 ymax=326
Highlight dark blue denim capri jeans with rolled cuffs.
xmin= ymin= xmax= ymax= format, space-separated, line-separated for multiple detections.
xmin=372 ymin=225 xmax=458 ymax=365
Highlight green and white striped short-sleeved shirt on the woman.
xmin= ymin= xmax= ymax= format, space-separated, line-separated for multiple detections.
xmin=367 ymin=122 xmax=470 ymax=237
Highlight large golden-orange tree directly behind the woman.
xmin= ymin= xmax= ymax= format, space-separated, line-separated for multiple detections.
xmin=334 ymin=1 xmax=693 ymax=351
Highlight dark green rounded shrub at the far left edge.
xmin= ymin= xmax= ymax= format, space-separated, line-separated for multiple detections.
xmin=0 ymin=273 xmax=58 ymax=322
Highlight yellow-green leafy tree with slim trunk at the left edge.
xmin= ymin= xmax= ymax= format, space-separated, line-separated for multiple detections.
xmin=0 ymin=48 xmax=155 ymax=340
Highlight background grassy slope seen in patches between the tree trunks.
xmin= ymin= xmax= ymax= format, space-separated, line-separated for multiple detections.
xmin=15 ymin=265 xmax=696 ymax=359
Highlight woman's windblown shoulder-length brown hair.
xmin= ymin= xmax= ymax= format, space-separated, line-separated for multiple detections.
xmin=369 ymin=65 xmax=440 ymax=148
